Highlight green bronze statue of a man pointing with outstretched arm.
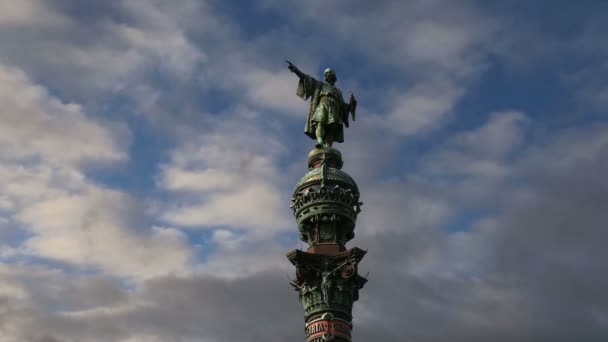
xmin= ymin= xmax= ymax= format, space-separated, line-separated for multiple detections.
xmin=287 ymin=61 xmax=357 ymax=148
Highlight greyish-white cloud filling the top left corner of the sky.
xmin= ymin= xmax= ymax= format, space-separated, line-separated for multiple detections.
xmin=0 ymin=1 xmax=205 ymax=99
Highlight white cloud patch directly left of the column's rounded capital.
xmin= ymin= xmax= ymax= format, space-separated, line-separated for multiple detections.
xmin=158 ymin=121 xmax=290 ymax=232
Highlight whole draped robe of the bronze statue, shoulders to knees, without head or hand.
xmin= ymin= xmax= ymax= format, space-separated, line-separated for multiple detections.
xmin=296 ymin=74 xmax=349 ymax=143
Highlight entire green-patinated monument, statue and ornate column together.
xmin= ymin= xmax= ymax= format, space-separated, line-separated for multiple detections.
xmin=287 ymin=62 xmax=367 ymax=342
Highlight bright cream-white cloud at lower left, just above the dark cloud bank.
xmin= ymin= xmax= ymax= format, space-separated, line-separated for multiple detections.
xmin=16 ymin=187 xmax=191 ymax=277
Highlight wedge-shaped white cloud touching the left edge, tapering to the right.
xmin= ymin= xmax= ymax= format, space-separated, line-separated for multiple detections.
xmin=0 ymin=65 xmax=129 ymax=163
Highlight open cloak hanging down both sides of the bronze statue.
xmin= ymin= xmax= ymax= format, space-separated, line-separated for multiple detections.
xmin=296 ymin=74 xmax=348 ymax=143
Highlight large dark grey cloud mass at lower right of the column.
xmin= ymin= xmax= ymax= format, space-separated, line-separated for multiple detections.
xmin=350 ymin=122 xmax=608 ymax=341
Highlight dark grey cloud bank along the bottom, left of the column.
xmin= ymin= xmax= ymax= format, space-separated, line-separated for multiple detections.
xmin=0 ymin=270 xmax=304 ymax=341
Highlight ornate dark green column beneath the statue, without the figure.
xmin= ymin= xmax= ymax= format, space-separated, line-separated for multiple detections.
xmin=287 ymin=147 xmax=367 ymax=342
